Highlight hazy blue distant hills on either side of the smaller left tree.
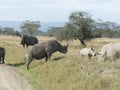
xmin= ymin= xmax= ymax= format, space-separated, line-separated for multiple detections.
xmin=0 ymin=21 xmax=65 ymax=32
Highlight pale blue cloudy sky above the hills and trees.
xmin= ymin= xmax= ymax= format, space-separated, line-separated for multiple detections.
xmin=0 ymin=0 xmax=120 ymax=24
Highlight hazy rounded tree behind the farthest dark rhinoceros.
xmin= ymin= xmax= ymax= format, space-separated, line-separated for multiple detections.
xmin=20 ymin=20 xmax=40 ymax=36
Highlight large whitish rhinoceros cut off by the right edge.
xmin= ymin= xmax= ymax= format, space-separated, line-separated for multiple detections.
xmin=99 ymin=43 xmax=120 ymax=61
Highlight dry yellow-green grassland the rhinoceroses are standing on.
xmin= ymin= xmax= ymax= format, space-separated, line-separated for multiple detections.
xmin=0 ymin=36 xmax=120 ymax=90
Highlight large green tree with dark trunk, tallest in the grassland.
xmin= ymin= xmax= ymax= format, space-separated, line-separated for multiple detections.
xmin=66 ymin=12 xmax=94 ymax=45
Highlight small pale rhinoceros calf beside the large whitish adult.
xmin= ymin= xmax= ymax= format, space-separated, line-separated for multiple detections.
xmin=80 ymin=48 xmax=96 ymax=58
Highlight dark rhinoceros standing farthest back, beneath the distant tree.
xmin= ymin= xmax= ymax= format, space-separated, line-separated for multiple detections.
xmin=21 ymin=35 xmax=38 ymax=47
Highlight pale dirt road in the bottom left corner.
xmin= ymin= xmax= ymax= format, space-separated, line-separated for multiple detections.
xmin=0 ymin=64 xmax=32 ymax=90
